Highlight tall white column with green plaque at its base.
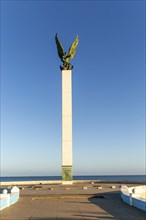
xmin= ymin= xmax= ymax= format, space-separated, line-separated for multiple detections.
xmin=62 ymin=70 xmax=72 ymax=184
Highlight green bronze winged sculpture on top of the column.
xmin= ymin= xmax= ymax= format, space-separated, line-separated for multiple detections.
xmin=55 ymin=34 xmax=79 ymax=70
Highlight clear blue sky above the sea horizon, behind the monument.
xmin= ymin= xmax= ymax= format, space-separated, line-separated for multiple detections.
xmin=1 ymin=0 xmax=145 ymax=176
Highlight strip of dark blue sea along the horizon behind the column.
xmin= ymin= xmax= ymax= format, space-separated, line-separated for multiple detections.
xmin=0 ymin=175 xmax=146 ymax=184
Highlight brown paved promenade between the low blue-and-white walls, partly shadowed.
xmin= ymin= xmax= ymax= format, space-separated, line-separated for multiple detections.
xmin=0 ymin=184 xmax=146 ymax=220
